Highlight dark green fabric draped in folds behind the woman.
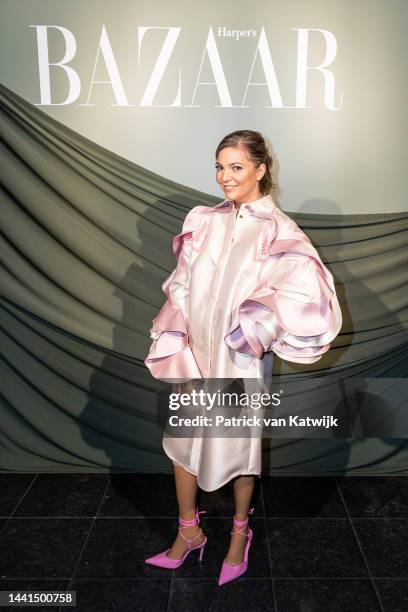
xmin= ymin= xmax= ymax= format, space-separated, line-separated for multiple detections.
xmin=0 ymin=86 xmax=408 ymax=476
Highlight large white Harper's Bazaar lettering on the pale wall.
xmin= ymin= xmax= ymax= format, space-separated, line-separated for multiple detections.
xmin=30 ymin=25 xmax=343 ymax=111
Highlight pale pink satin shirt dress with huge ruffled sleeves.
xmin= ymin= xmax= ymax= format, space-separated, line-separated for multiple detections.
xmin=145 ymin=195 xmax=342 ymax=491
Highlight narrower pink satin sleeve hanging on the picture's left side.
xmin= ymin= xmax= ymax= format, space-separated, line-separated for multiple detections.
xmin=145 ymin=209 xmax=201 ymax=382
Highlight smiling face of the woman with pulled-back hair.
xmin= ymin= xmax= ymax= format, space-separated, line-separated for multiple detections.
xmin=215 ymin=147 xmax=266 ymax=204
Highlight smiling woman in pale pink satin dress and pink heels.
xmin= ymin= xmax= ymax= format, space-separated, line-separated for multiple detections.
xmin=145 ymin=130 xmax=342 ymax=584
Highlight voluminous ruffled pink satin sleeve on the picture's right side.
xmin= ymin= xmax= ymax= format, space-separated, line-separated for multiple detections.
xmin=225 ymin=249 xmax=342 ymax=363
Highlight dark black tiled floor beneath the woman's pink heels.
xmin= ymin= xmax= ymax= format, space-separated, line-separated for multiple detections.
xmin=0 ymin=474 xmax=408 ymax=612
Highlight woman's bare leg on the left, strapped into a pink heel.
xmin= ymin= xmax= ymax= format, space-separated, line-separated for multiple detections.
xmin=167 ymin=463 xmax=205 ymax=559
